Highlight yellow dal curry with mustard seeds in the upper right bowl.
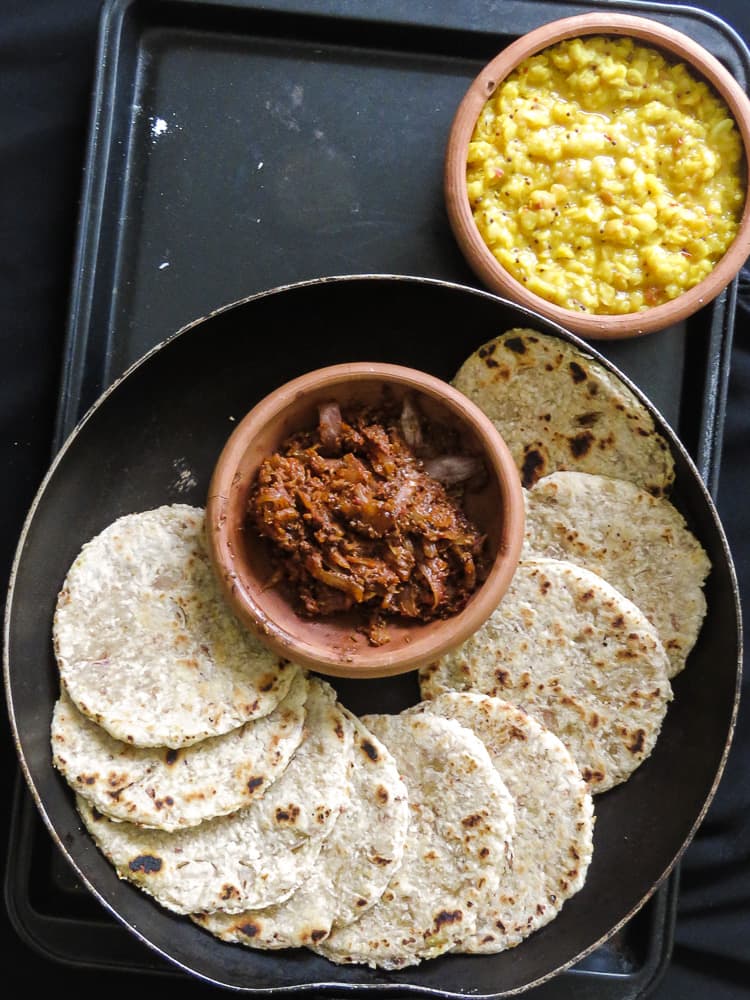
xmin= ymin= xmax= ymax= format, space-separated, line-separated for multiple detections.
xmin=467 ymin=36 xmax=745 ymax=314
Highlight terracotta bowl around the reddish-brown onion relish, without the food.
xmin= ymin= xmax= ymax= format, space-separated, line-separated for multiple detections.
xmin=206 ymin=363 xmax=524 ymax=678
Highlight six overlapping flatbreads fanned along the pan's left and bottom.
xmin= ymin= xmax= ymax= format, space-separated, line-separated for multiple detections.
xmin=51 ymin=504 xmax=594 ymax=969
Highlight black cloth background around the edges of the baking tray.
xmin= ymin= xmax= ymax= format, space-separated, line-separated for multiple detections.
xmin=0 ymin=0 xmax=750 ymax=1000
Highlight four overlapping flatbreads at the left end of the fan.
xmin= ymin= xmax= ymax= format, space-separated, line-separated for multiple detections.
xmin=51 ymin=504 xmax=408 ymax=947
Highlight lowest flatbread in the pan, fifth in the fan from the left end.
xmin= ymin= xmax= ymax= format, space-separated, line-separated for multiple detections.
xmin=313 ymin=713 xmax=514 ymax=969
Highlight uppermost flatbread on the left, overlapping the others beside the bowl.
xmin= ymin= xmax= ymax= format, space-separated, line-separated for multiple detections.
xmin=53 ymin=504 xmax=297 ymax=749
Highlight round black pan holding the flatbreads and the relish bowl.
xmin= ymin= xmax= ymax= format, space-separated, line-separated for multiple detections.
xmin=5 ymin=276 xmax=741 ymax=997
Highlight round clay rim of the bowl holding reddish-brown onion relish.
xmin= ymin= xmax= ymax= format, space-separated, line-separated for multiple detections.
xmin=206 ymin=362 xmax=525 ymax=679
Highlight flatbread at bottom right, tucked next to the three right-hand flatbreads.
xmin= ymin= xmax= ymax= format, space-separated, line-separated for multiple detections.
xmin=409 ymin=691 xmax=594 ymax=954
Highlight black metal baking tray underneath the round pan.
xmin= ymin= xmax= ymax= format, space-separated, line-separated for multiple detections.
xmin=5 ymin=0 xmax=750 ymax=1000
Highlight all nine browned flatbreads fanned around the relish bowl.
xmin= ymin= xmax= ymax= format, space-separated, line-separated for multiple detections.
xmin=51 ymin=330 xmax=710 ymax=969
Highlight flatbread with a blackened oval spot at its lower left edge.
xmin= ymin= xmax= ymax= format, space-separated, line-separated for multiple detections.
xmin=76 ymin=678 xmax=352 ymax=914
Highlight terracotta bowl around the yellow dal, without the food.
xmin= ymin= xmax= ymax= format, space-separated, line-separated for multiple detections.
xmin=444 ymin=11 xmax=750 ymax=339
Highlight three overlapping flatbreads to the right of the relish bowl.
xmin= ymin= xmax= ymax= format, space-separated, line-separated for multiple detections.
xmin=420 ymin=329 xmax=710 ymax=793
